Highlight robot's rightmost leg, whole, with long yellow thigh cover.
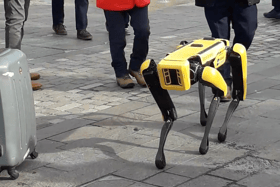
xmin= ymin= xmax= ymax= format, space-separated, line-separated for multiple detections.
xmin=218 ymin=44 xmax=247 ymax=142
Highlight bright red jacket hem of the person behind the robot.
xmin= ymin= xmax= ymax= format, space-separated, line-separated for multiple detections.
xmin=96 ymin=0 xmax=150 ymax=11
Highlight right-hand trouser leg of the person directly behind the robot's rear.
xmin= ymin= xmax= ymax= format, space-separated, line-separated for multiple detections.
xmin=232 ymin=5 xmax=258 ymax=49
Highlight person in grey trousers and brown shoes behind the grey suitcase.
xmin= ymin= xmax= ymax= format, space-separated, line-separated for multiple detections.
xmin=4 ymin=0 xmax=42 ymax=90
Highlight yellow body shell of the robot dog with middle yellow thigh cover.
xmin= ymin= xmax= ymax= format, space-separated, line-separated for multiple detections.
xmin=157 ymin=39 xmax=229 ymax=94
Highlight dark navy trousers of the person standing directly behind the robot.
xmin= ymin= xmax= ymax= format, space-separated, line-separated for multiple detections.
xmin=204 ymin=0 xmax=257 ymax=86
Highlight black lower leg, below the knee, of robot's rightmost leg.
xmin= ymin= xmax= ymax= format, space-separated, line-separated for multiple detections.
xmin=218 ymin=98 xmax=240 ymax=142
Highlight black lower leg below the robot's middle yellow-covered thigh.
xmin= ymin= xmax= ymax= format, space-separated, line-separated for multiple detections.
xmin=199 ymin=95 xmax=220 ymax=155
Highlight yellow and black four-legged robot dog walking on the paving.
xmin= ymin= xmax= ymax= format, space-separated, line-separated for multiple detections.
xmin=141 ymin=38 xmax=247 ymax=169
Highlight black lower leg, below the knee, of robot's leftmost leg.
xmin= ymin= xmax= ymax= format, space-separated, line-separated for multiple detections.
xmin=155 ymin=119 xmax=173 ymax=169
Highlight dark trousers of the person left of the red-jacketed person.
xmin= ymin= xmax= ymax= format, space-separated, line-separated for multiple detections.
xmin=52 ymin=0 xmax=88 ymax=30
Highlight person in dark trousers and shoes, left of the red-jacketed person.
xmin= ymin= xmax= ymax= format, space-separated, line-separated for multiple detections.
xmin=52 ymin=0 xmax=92 ymax=40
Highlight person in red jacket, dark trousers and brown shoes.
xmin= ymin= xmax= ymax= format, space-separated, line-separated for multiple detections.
xmin=96 ymin=0 xmax=150 ymax=88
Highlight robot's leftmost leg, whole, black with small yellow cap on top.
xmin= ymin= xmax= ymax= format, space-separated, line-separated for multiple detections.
xmin=141 ymin=60 xmax=177 ymax=169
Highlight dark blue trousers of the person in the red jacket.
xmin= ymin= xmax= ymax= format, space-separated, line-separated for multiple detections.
xmin=104 ymin=7 xmax=150 ymax=77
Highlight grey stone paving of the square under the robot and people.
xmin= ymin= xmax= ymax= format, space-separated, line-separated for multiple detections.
xmin=0 ymin=0 xmax=280 ymax=187
